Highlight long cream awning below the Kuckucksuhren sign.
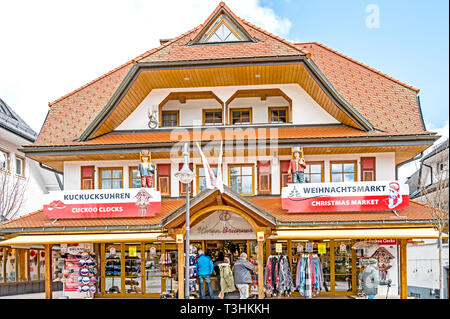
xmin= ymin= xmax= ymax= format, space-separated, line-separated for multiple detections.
xmin=0 ymin=233 xmax=163 ymax=246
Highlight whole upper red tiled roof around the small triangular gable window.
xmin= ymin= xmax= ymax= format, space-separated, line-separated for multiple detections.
xmin=35 ymin=3 xmax=426 ymax=145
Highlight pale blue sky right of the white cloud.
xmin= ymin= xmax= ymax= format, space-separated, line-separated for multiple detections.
xmin=272 ymin=0 xmax=449 ymax=130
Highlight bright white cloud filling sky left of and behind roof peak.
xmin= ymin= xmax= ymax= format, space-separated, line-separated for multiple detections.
xmin=0 ymin=0 xmax=291 ymax=131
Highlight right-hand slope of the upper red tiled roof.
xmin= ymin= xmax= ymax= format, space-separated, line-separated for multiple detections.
xmin=296 ymin=42 xmax=425 ymax=134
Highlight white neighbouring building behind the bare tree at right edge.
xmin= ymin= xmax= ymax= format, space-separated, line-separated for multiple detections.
xmin=406 ymin=139 xmax=449 ymax=298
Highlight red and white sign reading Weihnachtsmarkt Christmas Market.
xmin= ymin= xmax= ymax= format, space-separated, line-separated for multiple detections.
xmin=281 ymin=181 xmax=409 ymax=213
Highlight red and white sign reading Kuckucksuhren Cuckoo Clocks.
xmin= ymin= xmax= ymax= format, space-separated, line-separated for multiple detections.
xmin=44 ymin=188 xmax=161 ymax=219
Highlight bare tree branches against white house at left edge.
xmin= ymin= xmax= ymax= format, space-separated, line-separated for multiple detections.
xmin=0 ymin=171 xmax=27 ymax=224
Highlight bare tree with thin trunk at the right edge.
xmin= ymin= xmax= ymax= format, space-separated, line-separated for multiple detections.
xmin=419 ymin=147 xmax=449 ymax=299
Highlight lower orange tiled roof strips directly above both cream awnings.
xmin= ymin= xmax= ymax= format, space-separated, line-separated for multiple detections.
xmin=0 ymin=197 xmax=432 ymax=233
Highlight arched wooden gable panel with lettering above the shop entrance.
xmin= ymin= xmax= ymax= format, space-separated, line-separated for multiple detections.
xmin=191 ymin=211 xmax=256 ymax=240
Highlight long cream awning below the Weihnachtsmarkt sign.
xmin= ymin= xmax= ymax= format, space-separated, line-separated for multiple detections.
xmin=269 ymin=228 xmax=448 ymax=239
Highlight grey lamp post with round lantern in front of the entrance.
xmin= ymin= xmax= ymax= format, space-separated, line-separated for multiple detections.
xmin=175 ymin=143 xmax=194 ymax=299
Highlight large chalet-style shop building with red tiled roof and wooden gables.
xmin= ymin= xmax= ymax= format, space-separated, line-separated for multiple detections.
xmin=0 ymin=2 xmax=444 ymax=298
